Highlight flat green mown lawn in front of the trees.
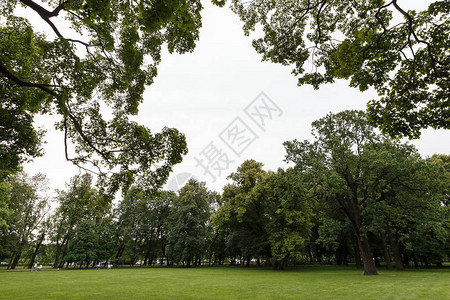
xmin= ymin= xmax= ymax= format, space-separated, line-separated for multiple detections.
xmin=0 ymin=266 xmax=450 ymax=300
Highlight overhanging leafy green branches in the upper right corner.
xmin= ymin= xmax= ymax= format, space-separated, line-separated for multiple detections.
xmin=232 ymin=0 xmax=450 ymax=138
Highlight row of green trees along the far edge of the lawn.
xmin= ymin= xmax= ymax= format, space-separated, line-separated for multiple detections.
xmin=0 ymin=111 xmax=450 ymax=274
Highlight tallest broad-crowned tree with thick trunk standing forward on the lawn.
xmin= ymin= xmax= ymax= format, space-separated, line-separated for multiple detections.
xmin=285 ymin=111 xmax=449 ymax=274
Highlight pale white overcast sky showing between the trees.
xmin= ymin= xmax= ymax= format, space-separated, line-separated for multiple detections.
xmin=24 ymin=0 xmax=450 ymax=192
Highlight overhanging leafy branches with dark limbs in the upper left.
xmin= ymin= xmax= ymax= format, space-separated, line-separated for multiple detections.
xmin=0 ymin=0 xmax=220 ymax=193
